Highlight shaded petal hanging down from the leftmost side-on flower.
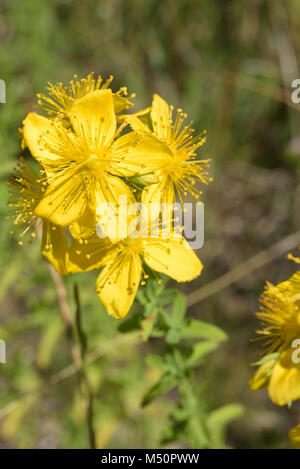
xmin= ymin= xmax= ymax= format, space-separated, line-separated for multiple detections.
xmin=41 ymin=221 xmax=72 ymax=275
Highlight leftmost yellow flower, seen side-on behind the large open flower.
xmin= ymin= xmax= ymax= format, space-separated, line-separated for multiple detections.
xmin=8 ymin=158 xmax=75 ymax=275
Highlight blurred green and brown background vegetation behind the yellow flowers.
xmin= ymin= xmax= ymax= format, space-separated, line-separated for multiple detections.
xmin=0 ymin=0 xmax=300 ymax=448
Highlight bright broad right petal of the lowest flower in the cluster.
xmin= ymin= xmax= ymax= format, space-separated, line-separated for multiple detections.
xmin=144 ymin=237 xmax=203 ymax=282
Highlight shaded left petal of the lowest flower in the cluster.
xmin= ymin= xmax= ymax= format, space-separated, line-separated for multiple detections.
xmin=70 ymin=233 xmax=118 ymax=272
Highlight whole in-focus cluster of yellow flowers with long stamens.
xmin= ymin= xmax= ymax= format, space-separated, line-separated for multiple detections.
xmin=9 ymin=74 xmax=211 ymax=318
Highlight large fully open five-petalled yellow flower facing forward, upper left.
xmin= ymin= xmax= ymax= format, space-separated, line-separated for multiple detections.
xmin=24 ymin=89 xmax=169 ymax=231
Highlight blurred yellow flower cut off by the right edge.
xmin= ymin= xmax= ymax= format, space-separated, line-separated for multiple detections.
xmin=249 ymin=272 xmax=300 ymax=406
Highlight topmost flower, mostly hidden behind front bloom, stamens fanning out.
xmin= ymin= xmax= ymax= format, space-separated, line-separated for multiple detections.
xmin=37 ymin=73 xmax=135 ymax=119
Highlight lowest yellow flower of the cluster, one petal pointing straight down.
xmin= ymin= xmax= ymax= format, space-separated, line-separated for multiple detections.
xmin=70 ymin=219 xmax=202 ymax=318
